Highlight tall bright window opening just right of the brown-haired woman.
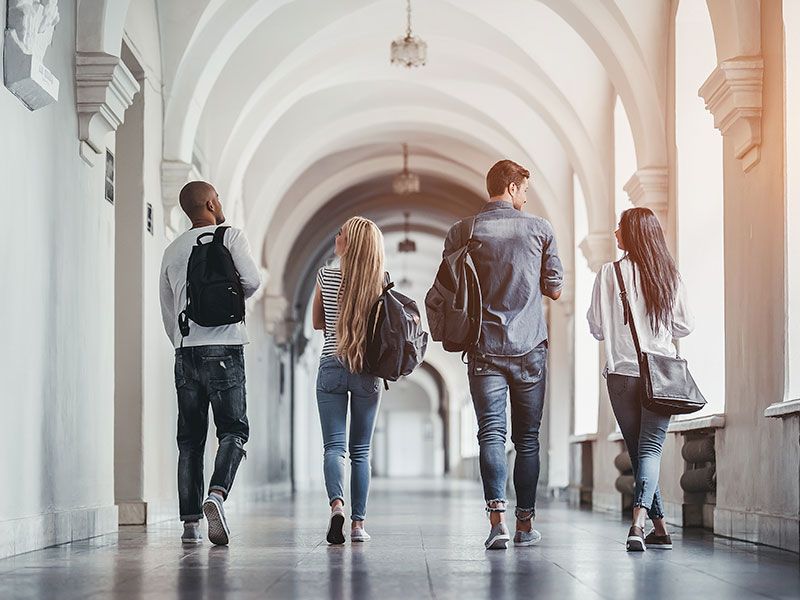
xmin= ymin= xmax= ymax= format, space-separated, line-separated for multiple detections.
xmin=675 ymin=0 xmax=725 ymax=417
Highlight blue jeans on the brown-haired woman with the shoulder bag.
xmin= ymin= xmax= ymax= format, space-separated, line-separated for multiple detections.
xmin=606 ymin=373 xmax=669 ymax=519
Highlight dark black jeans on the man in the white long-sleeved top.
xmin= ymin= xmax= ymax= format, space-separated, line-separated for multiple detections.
xmin=175 ymin=346 xmax=250 ymax=521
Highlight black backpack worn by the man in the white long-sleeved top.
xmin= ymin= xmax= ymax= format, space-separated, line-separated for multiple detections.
xmin=178 ymin=226 xmax=244 ymax=337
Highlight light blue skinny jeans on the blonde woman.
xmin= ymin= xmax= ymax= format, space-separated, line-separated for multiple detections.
xmin=317 ymin=356 xmax=381 ymax=521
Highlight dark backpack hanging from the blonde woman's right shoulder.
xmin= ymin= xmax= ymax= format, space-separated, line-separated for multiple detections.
xmin=364 ymin=275 xmax=428 ymax=390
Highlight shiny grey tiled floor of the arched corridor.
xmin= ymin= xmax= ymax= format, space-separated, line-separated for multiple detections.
xmin=0 ymin=481 xmax=800 ymax=600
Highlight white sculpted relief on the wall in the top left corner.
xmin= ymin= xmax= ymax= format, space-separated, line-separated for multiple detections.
xmin=3 ymin=0 xmax=60 ymax=111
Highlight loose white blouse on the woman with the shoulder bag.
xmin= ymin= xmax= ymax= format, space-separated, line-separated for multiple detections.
xmin=586 ymin=258 xmax=694 ymax=377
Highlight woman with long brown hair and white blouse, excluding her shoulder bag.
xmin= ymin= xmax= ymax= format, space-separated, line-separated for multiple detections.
xmin=586 ymin=208 xmax=694 ymax=552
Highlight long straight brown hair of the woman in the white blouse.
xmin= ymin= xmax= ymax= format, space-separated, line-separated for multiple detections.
xmin=619 ymin=207 xmax=680 ymax=332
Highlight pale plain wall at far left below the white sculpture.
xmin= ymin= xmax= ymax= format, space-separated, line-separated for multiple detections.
xmin=0 ymin=0 xmax=117 ymax=556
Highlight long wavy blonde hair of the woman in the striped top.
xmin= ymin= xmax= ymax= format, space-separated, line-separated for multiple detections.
xmin=336 ymin=217 xmax=384 ymax=373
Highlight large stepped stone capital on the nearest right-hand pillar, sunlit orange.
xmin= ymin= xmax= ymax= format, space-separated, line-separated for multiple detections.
xmin=698 ymin=56 xmax=764 ymax=173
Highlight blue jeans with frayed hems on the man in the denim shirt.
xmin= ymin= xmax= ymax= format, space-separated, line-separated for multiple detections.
xmin=469 ymin=341 xmax=547 ymax=512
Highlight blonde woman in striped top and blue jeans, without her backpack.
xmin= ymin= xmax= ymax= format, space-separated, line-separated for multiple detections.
xmin=313 ymin=217 xmax=384 ymax=544
